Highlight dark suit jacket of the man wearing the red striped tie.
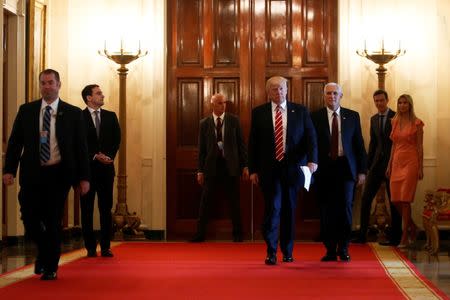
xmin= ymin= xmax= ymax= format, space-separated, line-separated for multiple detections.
xmin=248 ymin=102 xmax=317 ymax=186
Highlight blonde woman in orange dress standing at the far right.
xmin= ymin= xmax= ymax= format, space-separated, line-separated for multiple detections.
xmin=386 ymin=94 xmax=424 ymax=248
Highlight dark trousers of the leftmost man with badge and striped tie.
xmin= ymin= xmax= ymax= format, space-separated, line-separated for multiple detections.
xmin=19 ymin=164 xmax=70 ymax=272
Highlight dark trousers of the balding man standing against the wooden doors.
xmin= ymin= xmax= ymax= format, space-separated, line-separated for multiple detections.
xmin=197 ymin=158 xmax=242 ymax=237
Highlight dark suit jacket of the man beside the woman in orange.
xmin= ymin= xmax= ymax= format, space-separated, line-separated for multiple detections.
xmin=367 ymin=109 xmax=395 ymax=172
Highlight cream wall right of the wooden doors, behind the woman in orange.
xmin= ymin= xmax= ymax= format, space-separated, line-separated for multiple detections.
xmin=338 ymin=0 xmax=450 ymax=224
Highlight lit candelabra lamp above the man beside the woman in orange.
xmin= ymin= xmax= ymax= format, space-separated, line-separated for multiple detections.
xmin=356 ymin=40 xmax=406 ymax=90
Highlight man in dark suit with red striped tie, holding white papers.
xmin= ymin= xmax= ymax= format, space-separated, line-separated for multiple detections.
xmin=248 ymin=76 xmax=317 ymax=265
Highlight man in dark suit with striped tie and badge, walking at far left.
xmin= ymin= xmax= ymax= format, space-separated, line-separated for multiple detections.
xmin=3 ymin=69 xmax=89 ymax=280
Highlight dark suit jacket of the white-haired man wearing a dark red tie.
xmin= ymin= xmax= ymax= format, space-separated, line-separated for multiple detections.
xmin=311 ymin=107 xmax=367 ymax=180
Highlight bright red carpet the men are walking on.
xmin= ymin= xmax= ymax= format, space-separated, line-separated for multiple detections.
xmin=0 ymin=243 xmax=448 ymax=300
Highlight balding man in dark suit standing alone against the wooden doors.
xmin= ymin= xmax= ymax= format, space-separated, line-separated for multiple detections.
xmin=191 ymin=94 xmax=248 ymax=242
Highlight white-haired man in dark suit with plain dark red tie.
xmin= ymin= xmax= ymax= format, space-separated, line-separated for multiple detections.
xmin=312 ymin=83 xmax=367 ymax=261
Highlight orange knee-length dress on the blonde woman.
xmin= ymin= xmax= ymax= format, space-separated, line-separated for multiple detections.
xmin=390 ymin=119 xmax=424 ymax=202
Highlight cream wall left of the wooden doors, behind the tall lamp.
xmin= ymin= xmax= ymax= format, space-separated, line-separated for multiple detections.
xmin=47 ymin=0 xmax=166 ymax=229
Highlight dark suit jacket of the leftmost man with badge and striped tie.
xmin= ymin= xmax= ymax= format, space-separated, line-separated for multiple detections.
xmin=4 ymin=99 xmax=90 ymax=186
